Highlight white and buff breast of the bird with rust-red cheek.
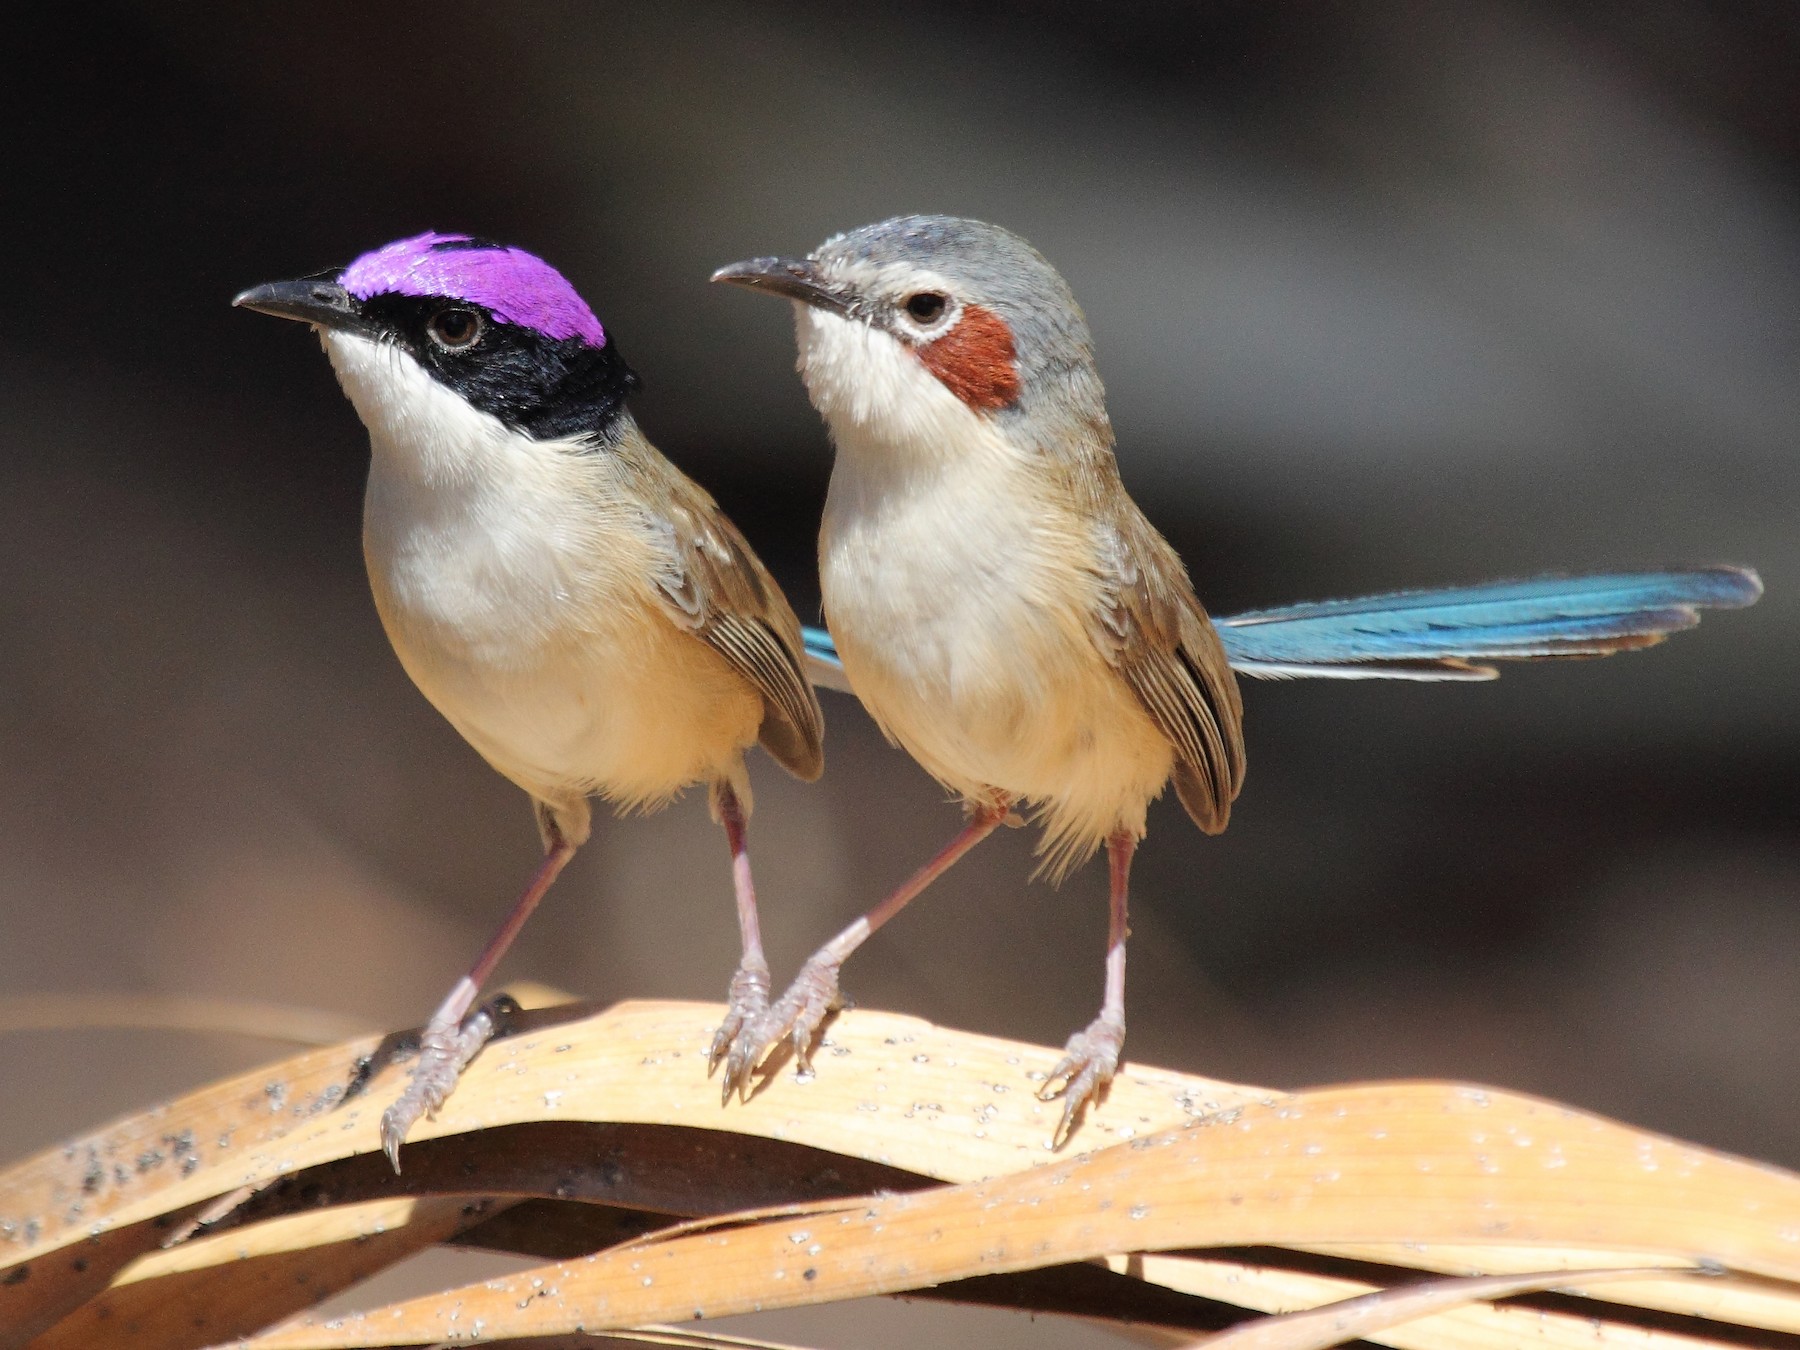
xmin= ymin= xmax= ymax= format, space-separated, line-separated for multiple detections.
xmin=821 ymin=446 xmax=1170 ymax=833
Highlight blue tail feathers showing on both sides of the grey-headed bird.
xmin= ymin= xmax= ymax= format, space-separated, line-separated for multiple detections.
xmin=805 ymin=567 xmax=1762 ymax=689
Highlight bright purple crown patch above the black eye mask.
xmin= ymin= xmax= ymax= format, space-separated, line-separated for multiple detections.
xmin=338 ymin=230 xmax=607 ymax=347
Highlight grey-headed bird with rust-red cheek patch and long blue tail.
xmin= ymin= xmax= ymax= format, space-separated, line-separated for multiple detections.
xmin=713 ymin=216 xmax=1760 ymax=1145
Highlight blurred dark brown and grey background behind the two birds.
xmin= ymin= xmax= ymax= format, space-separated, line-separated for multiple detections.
xmin=0 ymin=0 xmax=1800 ymax=1324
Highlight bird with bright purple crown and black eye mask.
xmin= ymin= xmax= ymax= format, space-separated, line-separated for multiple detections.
xmin=234 ymin=234 xmax=824 ymax=1170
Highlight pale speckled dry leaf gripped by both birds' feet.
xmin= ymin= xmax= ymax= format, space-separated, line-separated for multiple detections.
xmin=0 ymin=1003 xmax=1273 ymax=1281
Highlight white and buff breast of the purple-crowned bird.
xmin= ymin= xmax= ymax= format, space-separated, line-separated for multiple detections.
xmin=364 ymin=417 xmax=761 ymax=803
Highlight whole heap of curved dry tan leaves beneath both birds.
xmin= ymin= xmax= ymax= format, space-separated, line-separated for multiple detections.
xmin=0 ymin=1003 xmax=1800 ymax=1350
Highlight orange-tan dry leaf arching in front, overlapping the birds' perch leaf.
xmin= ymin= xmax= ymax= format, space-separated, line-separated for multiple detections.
xmin=232 ymin=1084 xmax=1800 ymax=1350
